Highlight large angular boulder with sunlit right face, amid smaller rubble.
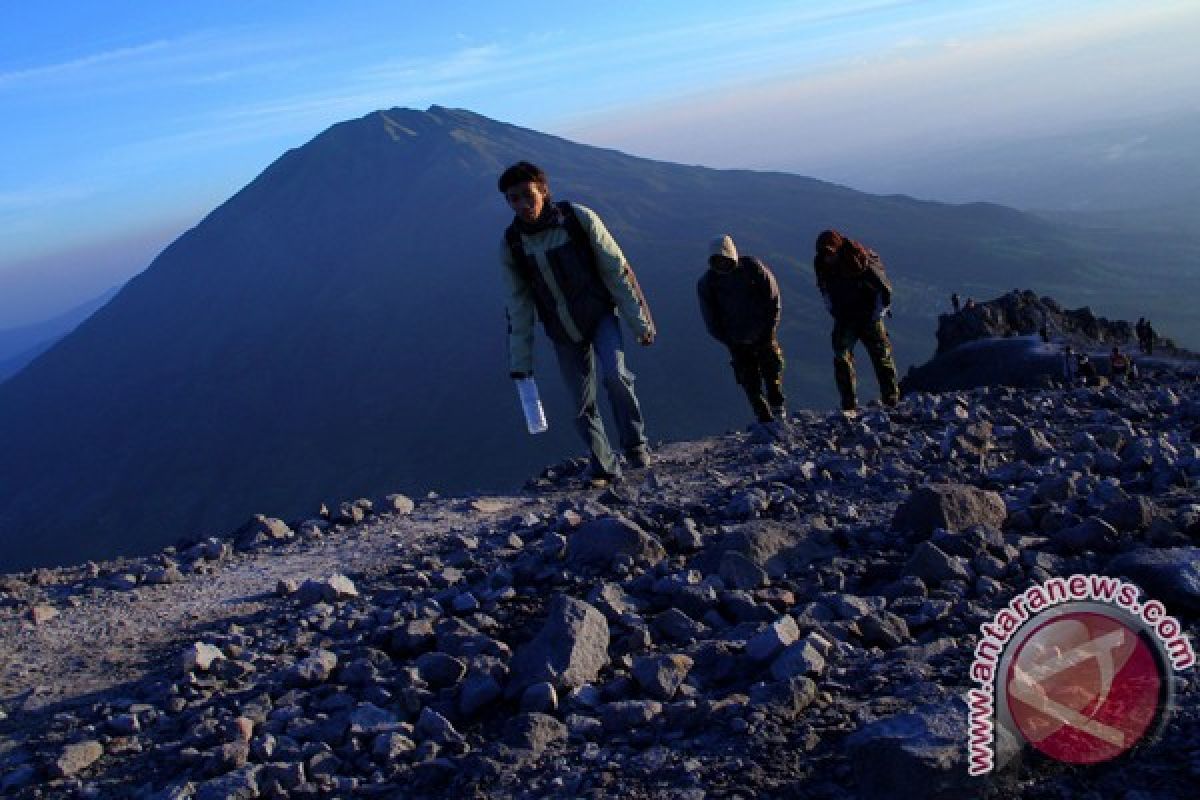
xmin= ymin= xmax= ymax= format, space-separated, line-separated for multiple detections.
xmin=506 ymin=595 xmax=608 ymax=697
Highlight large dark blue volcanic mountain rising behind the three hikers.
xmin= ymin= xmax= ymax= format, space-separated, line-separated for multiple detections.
xmin=0 ymin=107 xmax=1190 ymax=569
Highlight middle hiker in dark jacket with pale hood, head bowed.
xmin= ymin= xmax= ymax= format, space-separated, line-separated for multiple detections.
xmin=696 ymin=234 xmax=787 ymax=422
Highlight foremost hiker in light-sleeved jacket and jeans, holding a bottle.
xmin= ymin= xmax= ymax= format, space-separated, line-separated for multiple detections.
xmin=497 ymin=161 xmax=655 ymax=487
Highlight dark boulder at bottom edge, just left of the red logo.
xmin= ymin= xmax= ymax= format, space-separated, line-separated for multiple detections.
xmin=846 ymin=699 xmax=978 ymax=800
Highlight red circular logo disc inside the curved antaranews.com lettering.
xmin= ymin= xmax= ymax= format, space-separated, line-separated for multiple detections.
xmin=1003 ymin=612 xmax=1165 ymax=764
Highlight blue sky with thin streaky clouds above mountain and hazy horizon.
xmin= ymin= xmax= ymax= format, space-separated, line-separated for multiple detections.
xmin=0 ymin=0 xmax=1200 ymax=327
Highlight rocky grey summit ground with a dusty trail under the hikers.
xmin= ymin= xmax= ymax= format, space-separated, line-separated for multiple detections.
xmin=0 ymin=372 xmax=1200 ymax=800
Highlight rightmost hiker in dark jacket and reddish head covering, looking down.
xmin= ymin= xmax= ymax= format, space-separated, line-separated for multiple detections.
xmin=812 ymin=230 xmax=900 ymax=410
